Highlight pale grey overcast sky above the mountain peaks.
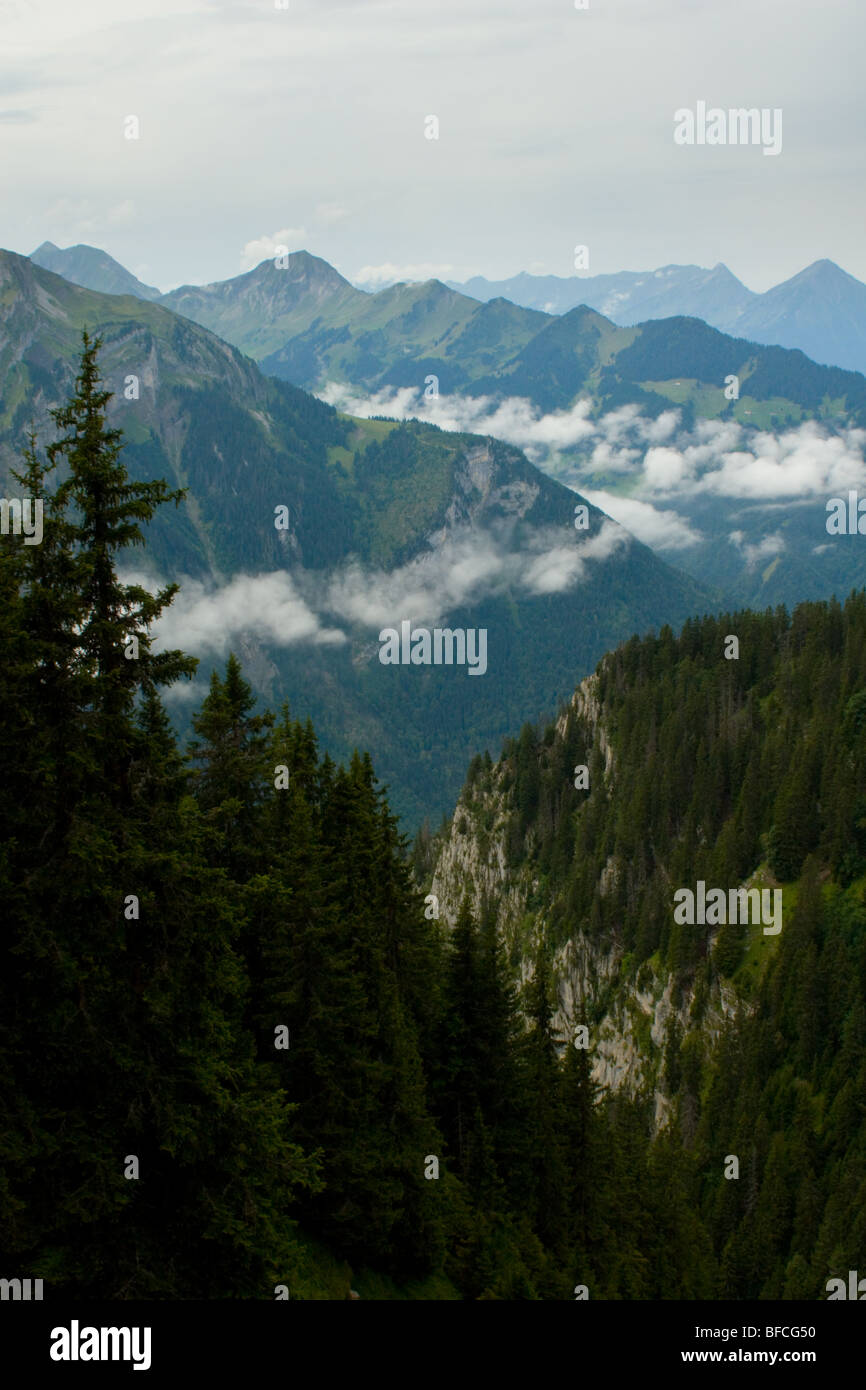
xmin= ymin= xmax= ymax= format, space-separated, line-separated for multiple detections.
xmin=0 ymin=0 xmax=866 ymax=291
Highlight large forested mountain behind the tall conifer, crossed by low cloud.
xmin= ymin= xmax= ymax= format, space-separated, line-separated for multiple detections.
xmin=0 ymin=252 xmax=714 ymax=823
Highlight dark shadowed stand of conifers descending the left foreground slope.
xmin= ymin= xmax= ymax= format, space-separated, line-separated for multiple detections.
xmin=0 ymin=333 xmax=711 ymax=1298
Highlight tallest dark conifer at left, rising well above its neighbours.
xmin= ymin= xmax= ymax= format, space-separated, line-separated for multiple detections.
xmin=0 ymin=336 xmax=316 ymax=1298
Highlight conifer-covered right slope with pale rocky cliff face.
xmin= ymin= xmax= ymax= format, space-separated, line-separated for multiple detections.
xmin=433 ymin=592 xmax=866 ymax=1298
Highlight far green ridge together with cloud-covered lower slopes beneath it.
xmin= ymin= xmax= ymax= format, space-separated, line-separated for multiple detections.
xmin=20 ymin=241 xmax=866 ymax=628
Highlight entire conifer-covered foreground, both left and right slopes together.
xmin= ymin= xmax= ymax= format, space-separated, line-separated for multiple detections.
xmin=0 ymin=345 xmax=866 ymax=1300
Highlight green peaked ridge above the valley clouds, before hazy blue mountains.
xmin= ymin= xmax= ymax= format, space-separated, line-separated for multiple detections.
xmin=152 ymin=252 xmax=866 ymax=427
